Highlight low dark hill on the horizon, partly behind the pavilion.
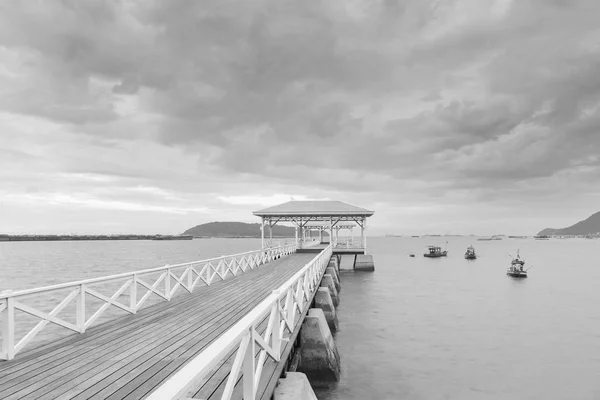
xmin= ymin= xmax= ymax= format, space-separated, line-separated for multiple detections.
xmin=182 ymin=222 xmax=295 ymax=238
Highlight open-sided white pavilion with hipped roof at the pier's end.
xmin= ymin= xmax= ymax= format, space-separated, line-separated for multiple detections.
xmin=253 ymin=200 xmax=374 ymax=254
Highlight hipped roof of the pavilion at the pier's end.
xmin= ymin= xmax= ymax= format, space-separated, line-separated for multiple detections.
xmin=253 ymin=200 xmax=375 ymax=217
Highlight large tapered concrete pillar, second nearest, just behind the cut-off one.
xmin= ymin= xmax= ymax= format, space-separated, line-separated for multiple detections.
xmin=298 ymin=308 xmax=340 ymax=382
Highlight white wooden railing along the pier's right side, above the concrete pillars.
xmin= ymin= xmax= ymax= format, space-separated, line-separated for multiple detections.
xmin=146 ymin=245 xmax=332 ymax=400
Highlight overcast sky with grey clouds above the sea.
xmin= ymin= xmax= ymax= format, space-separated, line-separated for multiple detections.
xmin=0 ymin=0 xmax=600 ymax=235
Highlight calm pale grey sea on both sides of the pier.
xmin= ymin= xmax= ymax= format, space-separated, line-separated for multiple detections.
xmin=0 ymin=237 xmax=600 ymax=400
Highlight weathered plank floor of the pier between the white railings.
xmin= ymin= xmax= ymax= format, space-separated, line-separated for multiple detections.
xmin=0 ymin=253 xmax=315 ymax=400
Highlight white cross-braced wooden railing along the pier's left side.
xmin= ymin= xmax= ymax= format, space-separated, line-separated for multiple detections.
xmin=0 ymin=244 xmax=296 ymax=360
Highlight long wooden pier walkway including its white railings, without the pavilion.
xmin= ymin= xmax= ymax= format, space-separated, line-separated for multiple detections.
xmin=0 ymin=202 xmax=376 ymax=400
